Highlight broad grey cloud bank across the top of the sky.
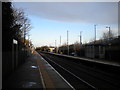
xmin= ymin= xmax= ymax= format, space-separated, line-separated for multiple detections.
xmin=13 ymin=2 xmax=118 ymax=24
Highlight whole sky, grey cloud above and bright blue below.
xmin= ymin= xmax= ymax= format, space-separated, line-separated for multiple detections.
xmin=13 ymin=2 xmax=118 ymax=47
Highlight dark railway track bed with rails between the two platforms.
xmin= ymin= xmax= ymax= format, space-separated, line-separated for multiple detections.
xmin=40 ymin=53 xmax=120 ymax=90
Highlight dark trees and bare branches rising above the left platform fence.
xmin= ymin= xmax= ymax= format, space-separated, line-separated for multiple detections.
xmin=2 ymin=2 xmax=31 ymax=51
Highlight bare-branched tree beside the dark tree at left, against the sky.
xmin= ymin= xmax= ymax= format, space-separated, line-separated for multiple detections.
xmin=13 ymin=9 xmax=31 ymax=44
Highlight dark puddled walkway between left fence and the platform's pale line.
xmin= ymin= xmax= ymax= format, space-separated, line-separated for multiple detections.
xmin=4 ymin=54 xmax=43 ymax=88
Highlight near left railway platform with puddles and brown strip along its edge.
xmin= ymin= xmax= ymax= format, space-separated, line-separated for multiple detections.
xmin=2 ymin=51 xmax=74 ymax=90
